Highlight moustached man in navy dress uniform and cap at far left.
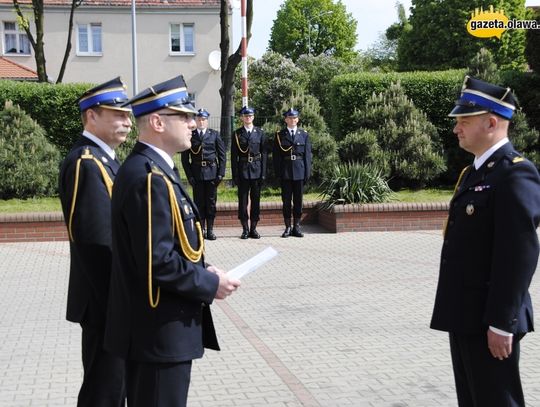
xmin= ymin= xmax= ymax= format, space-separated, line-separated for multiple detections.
xmin=58 ymin=77 xmax=132 ymax=407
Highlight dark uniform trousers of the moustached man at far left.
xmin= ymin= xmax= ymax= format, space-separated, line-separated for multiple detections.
xmin=77 ymin=323 xmax=126 ymax=407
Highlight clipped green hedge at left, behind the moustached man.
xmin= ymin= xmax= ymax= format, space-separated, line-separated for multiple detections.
xmin=0 ymin=80 xmax=93 ymax=155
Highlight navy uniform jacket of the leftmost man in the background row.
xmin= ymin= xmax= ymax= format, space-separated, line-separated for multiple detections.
xmin=182 ymin=129 xmax=226 ymax=181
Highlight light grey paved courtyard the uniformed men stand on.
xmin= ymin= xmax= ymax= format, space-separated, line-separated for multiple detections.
xmin=0 ymin=226 xmax=540 ymax=407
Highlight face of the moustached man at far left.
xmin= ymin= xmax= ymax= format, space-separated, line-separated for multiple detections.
xmin=87 ymin=108 xmax=132 ymax=149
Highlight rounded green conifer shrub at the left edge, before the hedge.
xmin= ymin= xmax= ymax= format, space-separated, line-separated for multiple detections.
xmin=0 ymin=102 xmax=60 ymax=199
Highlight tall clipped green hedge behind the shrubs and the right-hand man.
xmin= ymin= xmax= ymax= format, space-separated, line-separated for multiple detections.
xmin=331 ymin=70 xmax=540 ymax=184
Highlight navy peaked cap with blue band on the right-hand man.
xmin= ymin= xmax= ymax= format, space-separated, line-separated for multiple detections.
xmin=448 ymin=76 xmax=517 ymax=120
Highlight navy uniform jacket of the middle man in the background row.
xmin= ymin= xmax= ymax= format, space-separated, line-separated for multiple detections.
xmin=231 ymin=127 xmax=268 ymax=180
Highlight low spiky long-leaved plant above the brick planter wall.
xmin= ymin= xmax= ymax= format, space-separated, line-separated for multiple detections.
xmin=321 ymin=163 xmax=392 ymax=209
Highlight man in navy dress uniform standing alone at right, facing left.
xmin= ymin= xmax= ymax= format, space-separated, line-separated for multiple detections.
xmin=431 ymin=77 xmax=540 ymax=407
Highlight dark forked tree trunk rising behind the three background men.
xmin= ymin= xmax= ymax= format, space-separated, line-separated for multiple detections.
xmin=219 ymin=0 xmax=253 ymax=144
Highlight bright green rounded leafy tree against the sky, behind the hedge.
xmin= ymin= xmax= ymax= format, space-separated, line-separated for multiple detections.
xmin=269 ymin=0 xmax=357 ymax=61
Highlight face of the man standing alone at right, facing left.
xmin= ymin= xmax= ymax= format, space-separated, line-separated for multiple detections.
xmin=454 ymin=113 xmax=494 ymax=156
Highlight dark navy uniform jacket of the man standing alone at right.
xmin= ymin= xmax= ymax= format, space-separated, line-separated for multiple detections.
xmin=431 ymin=143 xmax=540 ymax=334
